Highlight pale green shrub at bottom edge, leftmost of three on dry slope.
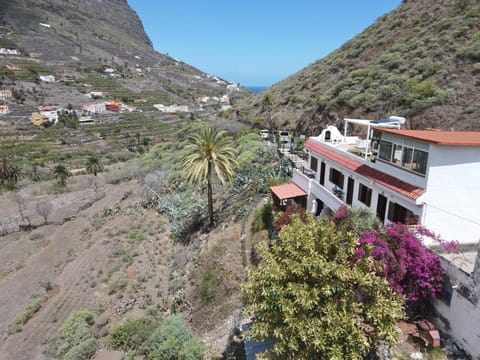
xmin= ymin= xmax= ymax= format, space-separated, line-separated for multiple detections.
xmin=56 ymin=310 xmax=97 ymax=360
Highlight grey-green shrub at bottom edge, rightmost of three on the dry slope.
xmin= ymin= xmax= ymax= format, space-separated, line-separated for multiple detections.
xmin=144 ymin=315 xmax=206 ymax=360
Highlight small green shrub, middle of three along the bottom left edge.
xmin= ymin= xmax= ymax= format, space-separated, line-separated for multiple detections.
xmin=107 ymin=319 xmax=154 ymax=351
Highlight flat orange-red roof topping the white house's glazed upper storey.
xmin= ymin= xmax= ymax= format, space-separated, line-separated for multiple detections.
xmin=375 ymin=128 xmax=480 ymax=146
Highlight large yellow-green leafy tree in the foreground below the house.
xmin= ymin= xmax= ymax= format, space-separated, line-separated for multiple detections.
xmin=243 ymin=215 xmax=403 ymax=360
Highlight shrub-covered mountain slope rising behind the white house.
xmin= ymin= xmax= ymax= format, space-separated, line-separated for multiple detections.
xmin=232 ymin=0 xmax=480 ymax=134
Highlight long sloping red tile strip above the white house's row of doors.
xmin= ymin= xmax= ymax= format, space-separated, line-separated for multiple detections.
xmin=305 ymin=139 xmax=425 ymax=200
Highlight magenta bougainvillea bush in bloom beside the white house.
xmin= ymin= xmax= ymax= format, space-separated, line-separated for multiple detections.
xmin=354 ymin=223 xmax=444 ymax=305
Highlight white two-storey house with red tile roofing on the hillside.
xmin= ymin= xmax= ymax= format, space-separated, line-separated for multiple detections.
xmin=280 ymin=119 xmax=480 ymax=244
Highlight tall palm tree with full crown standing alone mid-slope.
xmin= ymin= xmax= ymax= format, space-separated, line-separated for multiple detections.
xmin=182 ymin=127 xmax=237 ymax=227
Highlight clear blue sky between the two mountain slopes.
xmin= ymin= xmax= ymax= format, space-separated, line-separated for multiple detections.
xmin=128 ymin=0 xmax=401 ymax=86
